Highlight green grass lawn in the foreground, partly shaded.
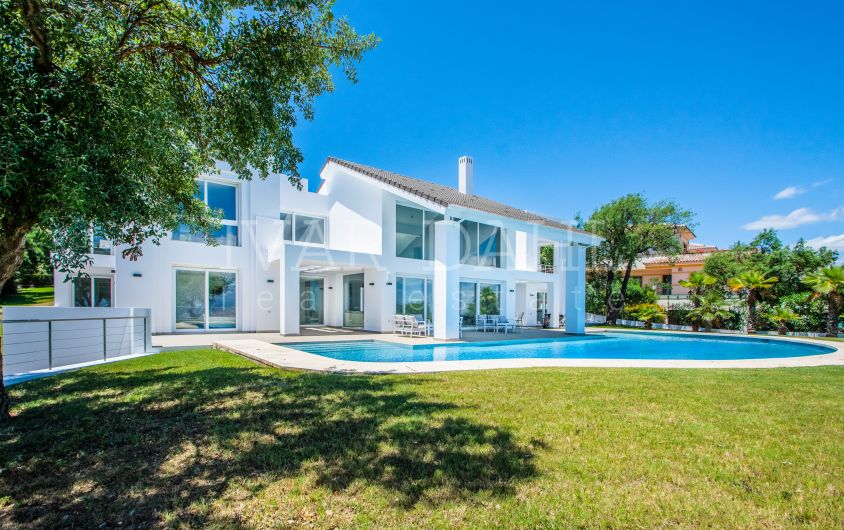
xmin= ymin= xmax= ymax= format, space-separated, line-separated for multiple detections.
xmin=0 ymin=350 xmax=844 ymax=528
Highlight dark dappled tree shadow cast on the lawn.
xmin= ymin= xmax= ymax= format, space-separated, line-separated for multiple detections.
xmin=0 ymin=356 xmax=537 ymax=528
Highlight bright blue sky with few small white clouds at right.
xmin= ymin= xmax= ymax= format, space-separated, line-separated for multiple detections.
xmin=296 ymin=0 xmax=844 ymax=250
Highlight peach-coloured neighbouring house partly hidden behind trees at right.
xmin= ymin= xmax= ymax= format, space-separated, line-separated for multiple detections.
xmin=630 ymin=226 xmax=721 ymax=298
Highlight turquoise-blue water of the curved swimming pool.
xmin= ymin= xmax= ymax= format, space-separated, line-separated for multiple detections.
xmin=283 ymin=331 xmax=835 ymax=362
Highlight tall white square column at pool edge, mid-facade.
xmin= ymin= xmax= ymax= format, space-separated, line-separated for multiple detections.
xmin=434 ymin=221 xmax=460 ymax=340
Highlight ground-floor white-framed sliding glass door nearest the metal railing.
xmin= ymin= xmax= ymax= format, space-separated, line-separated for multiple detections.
xmin=175 ymin=269 xmax=237 ymax=331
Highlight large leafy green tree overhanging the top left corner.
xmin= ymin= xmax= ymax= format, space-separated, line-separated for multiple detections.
xmin=0 ymin=0 xmax=376 ymax=417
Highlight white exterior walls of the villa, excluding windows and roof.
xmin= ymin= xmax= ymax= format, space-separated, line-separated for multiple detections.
xmin=55 ymin=163 xmax=592 ymax=334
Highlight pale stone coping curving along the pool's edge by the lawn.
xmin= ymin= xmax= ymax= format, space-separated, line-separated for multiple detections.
xmin=211 ymin=330 xmax=844 ymax=374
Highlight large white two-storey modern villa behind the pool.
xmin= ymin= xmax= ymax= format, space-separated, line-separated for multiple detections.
xmin=55 ymin=157 xmax=600 ymax=338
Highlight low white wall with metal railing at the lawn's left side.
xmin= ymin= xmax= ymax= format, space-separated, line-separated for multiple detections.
xmin=2 ymin=315 xmax=151 ymax=375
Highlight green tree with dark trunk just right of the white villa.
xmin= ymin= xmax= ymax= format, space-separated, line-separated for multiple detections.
xmin=579 ymin=193 xmax=693 ymax=324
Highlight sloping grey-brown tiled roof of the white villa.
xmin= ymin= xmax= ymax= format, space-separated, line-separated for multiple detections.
xmin=326 ymin=157 xmax=591 ymax=235
